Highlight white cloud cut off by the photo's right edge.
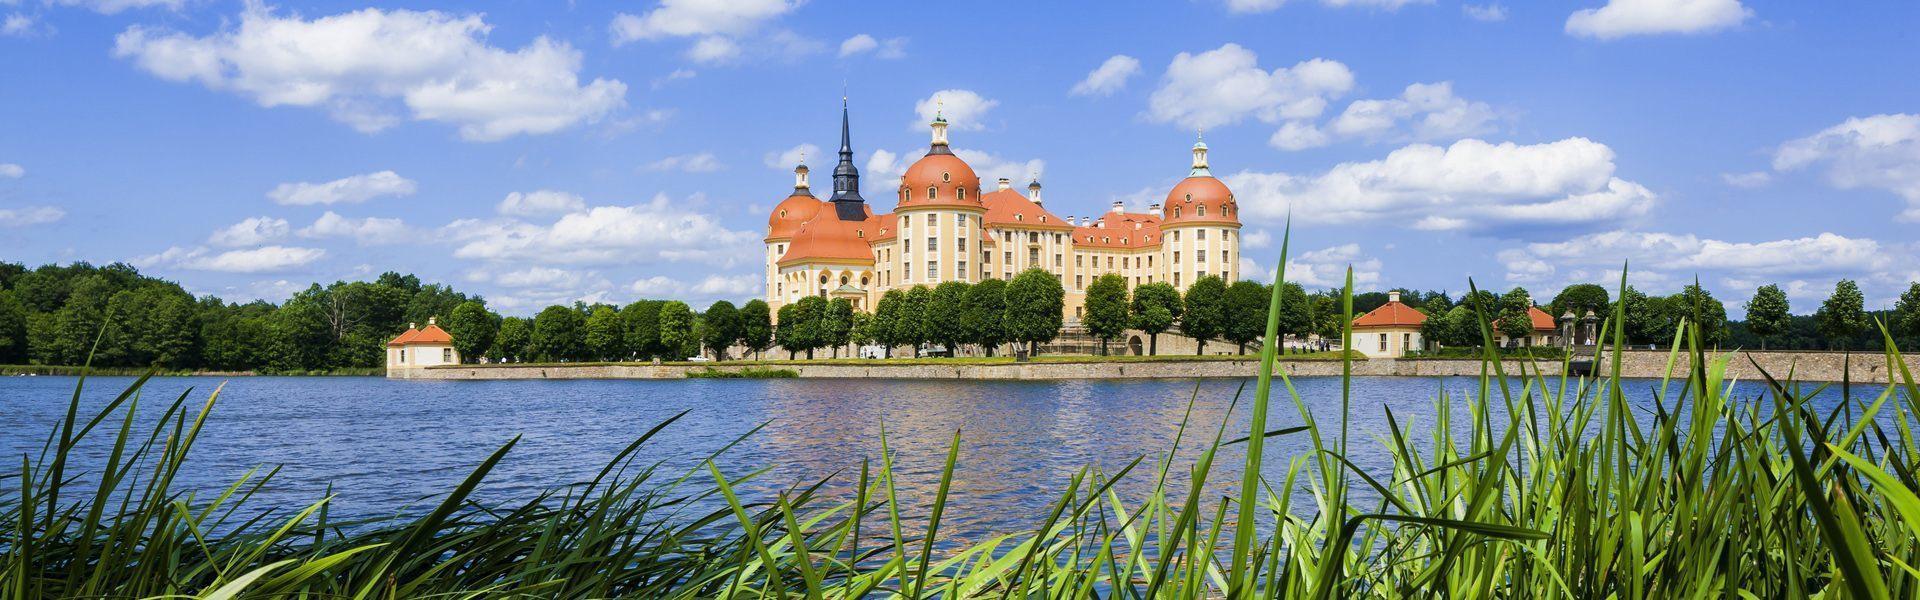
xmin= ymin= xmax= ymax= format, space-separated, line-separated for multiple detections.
xmin=1774 ymin=113 xmax=1920 ymax=221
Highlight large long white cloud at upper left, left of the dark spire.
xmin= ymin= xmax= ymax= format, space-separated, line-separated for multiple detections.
xmin=113 ymin=4 xmax=626 ymax=140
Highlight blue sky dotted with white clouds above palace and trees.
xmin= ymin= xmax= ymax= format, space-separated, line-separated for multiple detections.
xmin=0 ymin=0 xmax=1920 ymax=313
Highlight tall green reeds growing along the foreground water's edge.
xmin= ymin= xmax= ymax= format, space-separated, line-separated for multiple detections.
xmin=0 ymin=236 xmax=1920 ymax=600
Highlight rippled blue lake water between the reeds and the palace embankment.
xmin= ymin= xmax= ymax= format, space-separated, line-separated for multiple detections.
xmin=0 ymin=377 xmax=1880 ymax=542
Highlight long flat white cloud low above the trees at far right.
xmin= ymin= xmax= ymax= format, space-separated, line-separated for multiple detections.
xmin=1498 ymin=231 xmax=1895 ymax=281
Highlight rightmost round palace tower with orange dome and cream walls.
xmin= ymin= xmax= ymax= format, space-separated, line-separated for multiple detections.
xmin=1160 ymin=134 xmax=1240 ymax=290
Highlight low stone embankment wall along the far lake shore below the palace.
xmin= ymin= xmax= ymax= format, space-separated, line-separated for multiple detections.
xmin=388 ymin=350 xmax=1920 ymax=383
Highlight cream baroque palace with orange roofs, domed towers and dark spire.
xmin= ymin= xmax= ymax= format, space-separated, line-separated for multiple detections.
xmin=766 ymin=106 xmax=1240 ymax=323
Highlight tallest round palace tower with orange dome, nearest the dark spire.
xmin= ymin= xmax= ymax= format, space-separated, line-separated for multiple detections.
xmin=895 ymin=106 xmax=987 ymax=285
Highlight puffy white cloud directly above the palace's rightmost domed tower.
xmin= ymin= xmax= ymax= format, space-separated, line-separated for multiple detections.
xmin=1146 ymin=44 xmax=1354 ymax=129
